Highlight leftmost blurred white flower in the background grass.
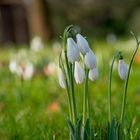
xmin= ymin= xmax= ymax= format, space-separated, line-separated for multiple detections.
xmin=9 ymin=59 xmax=17 ymax=73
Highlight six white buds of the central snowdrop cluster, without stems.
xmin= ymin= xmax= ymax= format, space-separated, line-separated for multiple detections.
xmin=58 ymin=34 xmax=98 ymax=88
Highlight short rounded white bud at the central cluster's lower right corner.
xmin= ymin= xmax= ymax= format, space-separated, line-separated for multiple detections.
xmin=88 ymin=67 xmax=99 ymax=81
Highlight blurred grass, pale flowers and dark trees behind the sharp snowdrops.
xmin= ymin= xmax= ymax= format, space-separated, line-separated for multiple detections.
xmin=0 ymin=0 xmax=140 ymax=140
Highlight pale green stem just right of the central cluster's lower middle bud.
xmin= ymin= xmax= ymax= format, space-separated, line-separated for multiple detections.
xmin=83 ymin=69 xmax=89 ymax=125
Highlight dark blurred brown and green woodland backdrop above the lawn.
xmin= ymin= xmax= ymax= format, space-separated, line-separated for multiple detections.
xmin=0 ymin=0 xmax=140 ymax=43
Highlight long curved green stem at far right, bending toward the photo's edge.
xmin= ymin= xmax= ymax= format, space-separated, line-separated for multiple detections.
xmin=120 ymin=41 xmax=140 ymax=126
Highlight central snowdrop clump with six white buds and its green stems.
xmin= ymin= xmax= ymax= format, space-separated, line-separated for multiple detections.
xmin=58 ymin=26 xmax=98 ymax=139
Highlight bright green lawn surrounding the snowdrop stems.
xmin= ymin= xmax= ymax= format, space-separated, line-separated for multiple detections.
xmin=0 ymin=40 xmax=140 ymax=140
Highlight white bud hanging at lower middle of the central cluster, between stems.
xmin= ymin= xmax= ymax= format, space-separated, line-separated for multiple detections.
xmin=74 ymin=62 xmax=85 ymax=84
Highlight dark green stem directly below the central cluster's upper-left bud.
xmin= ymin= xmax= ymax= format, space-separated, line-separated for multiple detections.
xmin=70 ymin=64 xmax=77 ymax=125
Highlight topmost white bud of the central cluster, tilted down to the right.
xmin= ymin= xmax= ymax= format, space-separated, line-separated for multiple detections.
xmin=76 ymin=34 xmax=90 ymax=55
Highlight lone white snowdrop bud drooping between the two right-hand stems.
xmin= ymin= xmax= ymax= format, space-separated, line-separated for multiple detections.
xmin=118 ymin=59 xmax=128 ymax=80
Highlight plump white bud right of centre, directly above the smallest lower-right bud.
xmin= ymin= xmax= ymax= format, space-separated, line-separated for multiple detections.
xmin=85 ymin=50 xmax=96 ymax=69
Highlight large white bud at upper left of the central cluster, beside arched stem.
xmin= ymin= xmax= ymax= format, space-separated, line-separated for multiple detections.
xmin=67 ymin=38 xmax=80 ymax=64
